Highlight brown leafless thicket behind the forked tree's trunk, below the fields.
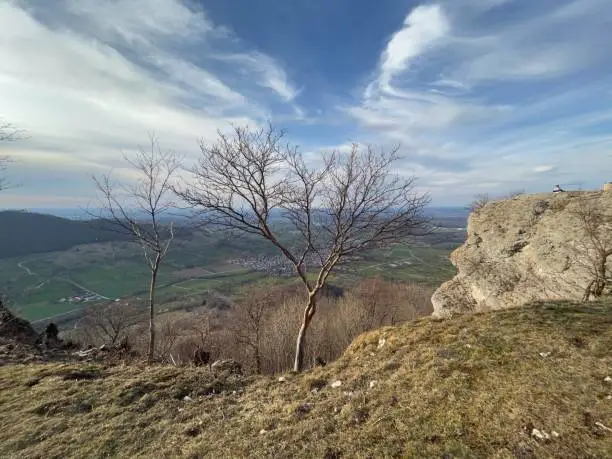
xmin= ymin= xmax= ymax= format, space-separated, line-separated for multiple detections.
xmin=71 ymin=279 xmax=433 ymax=374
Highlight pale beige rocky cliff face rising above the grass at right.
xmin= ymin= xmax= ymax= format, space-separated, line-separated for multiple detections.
xmin=432 ymin=191 xmax=612 ymax=316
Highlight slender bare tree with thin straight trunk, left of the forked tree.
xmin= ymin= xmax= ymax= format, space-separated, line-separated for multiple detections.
xmin=94 ymin=138 xmax=180 ymax=362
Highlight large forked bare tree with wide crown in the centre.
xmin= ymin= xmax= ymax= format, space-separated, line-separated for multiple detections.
xmin=177 ymin=126 xmax=429 ymax=371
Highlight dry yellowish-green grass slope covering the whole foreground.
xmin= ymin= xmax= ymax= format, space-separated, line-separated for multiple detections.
xmin=0 ymin=301 xmax=612 ymax=459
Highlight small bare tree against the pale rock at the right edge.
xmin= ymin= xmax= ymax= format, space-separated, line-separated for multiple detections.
xmin=575 ymin=199 xmax=612 ymax=301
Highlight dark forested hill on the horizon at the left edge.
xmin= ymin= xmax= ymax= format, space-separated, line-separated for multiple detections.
xmin=0 ymin=210 xmax=126 ymax=258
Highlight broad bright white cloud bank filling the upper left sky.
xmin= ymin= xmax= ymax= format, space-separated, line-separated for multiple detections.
xmin=0 ymin=0 xmax=295 ymax=206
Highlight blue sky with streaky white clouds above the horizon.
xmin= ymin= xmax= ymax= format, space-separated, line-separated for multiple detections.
xmin=0 ymin=0 xmax=612 ymax=208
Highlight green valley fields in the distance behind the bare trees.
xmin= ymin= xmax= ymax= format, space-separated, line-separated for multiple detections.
xmin=0 ymin=227 xmax=455 ymax=321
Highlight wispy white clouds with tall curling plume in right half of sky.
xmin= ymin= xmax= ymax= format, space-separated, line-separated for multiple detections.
xmin=345 ymin=0 xmax=612 ymax=205
